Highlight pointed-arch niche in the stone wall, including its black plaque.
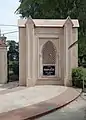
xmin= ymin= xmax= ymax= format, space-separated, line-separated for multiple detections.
xmin=42 ymin=41 xmax=56 ymax=77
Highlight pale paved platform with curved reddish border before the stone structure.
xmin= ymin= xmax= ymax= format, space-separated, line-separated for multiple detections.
xmin=0 ymin=84 xmax=80 ymax=120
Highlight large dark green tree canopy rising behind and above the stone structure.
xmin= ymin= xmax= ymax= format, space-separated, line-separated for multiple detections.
xmin=17 ymin=0 xmax=86 ymax=65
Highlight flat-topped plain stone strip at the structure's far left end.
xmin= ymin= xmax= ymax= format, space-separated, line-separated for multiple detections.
xmin=19 ymin=27 xmax=26 ymax=86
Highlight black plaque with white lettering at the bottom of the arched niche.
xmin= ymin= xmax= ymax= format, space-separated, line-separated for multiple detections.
xmin=43 ymin=65 xmax=55 ymax=76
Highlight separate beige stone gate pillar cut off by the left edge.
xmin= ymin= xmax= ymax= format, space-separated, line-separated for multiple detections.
xmin=0 ymin=36 xmax=7 ymax=84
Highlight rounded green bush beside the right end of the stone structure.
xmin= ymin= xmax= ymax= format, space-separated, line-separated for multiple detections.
xmin=72 ymin=67 xmax=86 ymax=88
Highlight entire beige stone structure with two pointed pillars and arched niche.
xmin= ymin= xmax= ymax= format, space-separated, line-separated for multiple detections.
xmin=18 ymin=17 xmax=79 ymax=87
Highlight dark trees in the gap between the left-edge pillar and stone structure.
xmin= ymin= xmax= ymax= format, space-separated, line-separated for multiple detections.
xmin=7 ymin=41 xmax=19 ymax=82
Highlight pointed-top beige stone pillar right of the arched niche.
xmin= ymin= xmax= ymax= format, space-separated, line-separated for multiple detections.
xmin=64 ymin=17 xmax=73 ymax=86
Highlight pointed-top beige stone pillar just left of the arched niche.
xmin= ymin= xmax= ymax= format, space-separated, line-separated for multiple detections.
xmin=26 ymin=18 xmax=36 ymax=87
